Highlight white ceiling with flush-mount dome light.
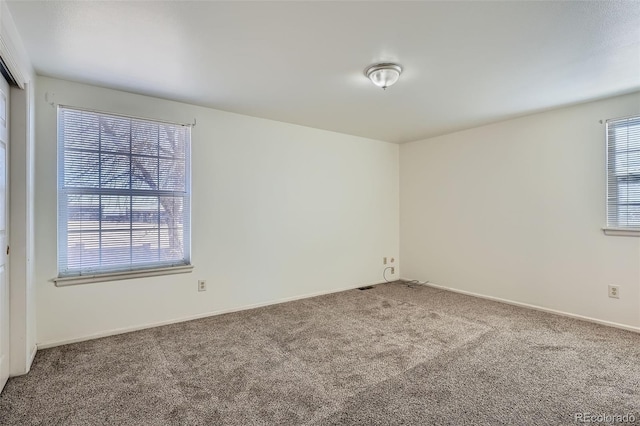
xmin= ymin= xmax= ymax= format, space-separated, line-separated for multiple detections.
xmin=8 ymin=0 xmax=640 ymax=142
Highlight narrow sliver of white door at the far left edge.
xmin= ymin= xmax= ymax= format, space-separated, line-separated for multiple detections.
xmin=0 ymin=77 xmax=9 ymax=391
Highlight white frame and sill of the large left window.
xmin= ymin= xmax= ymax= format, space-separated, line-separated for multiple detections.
xmin=52 ymin=105 xmax=195 ymax=286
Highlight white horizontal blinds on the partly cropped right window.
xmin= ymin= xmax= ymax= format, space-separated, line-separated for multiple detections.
xmin=607 ymin=117 xmax=640 ymax=228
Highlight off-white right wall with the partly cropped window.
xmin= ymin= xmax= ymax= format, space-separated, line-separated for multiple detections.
xmin=400 ymin=93 xmax=640 ymax=327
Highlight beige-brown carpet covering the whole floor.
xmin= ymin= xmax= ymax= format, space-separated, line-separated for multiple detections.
xmin=0 ymin=282 xmax=640 ymax=426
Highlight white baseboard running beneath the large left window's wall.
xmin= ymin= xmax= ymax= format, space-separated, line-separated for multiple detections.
xmin=32 ymin=282 xmax=381 ymax=350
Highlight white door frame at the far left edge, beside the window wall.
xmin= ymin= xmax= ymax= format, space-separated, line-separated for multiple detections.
xmin=0 ymin=1 xmax=37 ymax=376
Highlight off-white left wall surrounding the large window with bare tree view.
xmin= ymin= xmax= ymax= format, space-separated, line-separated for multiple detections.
xmin=35 ymin=77 xmax=399 ymax=346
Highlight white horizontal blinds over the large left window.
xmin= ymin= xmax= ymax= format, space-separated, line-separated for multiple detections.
xmin=58 ymin=107 xmax=191 ymax=276
